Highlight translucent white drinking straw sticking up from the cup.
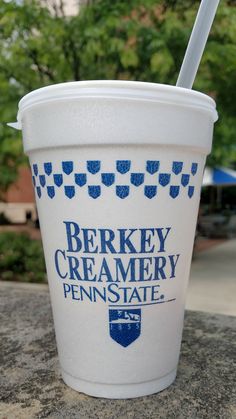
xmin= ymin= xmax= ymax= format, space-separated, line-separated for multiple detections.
xmin=176 ymin=0 xmax=219 ymax=89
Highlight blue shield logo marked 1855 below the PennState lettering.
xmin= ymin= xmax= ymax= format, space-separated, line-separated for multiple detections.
xmin=109 ymin=308 xmax=141 ymax=348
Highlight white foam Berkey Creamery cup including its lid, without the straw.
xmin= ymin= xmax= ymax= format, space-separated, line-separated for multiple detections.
xmin=14 ymin=81 xmax=217 ymax=398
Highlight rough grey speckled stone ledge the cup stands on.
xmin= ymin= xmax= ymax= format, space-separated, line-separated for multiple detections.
xmin=0 ymin=282 xmax=236 ymax=419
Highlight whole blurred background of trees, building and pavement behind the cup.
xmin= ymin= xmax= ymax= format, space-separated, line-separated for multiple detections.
xmin=0 ymin=0 xmax=236 ymax=315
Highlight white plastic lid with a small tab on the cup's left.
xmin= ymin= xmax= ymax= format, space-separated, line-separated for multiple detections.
xmin=9 ymin=80 xmax=218 ymax=129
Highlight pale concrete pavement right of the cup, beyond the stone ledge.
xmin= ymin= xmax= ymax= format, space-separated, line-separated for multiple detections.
xmin=186 ymin=239 xmax=236 ymax=316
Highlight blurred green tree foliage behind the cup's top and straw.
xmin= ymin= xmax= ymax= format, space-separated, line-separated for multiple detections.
xmin=0 ymin=0 xmax=236 ymax=194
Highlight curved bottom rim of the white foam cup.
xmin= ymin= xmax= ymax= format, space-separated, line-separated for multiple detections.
xmin=61 ymin=369 xmax=177 ymax=399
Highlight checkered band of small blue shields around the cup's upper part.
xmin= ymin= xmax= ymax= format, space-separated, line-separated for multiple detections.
xmin=32 ymin=160 xmax=198 ymax=199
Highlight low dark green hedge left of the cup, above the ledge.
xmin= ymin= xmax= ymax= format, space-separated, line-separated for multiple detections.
xmin=0 ymin=232 xmax=47 ymax=283
